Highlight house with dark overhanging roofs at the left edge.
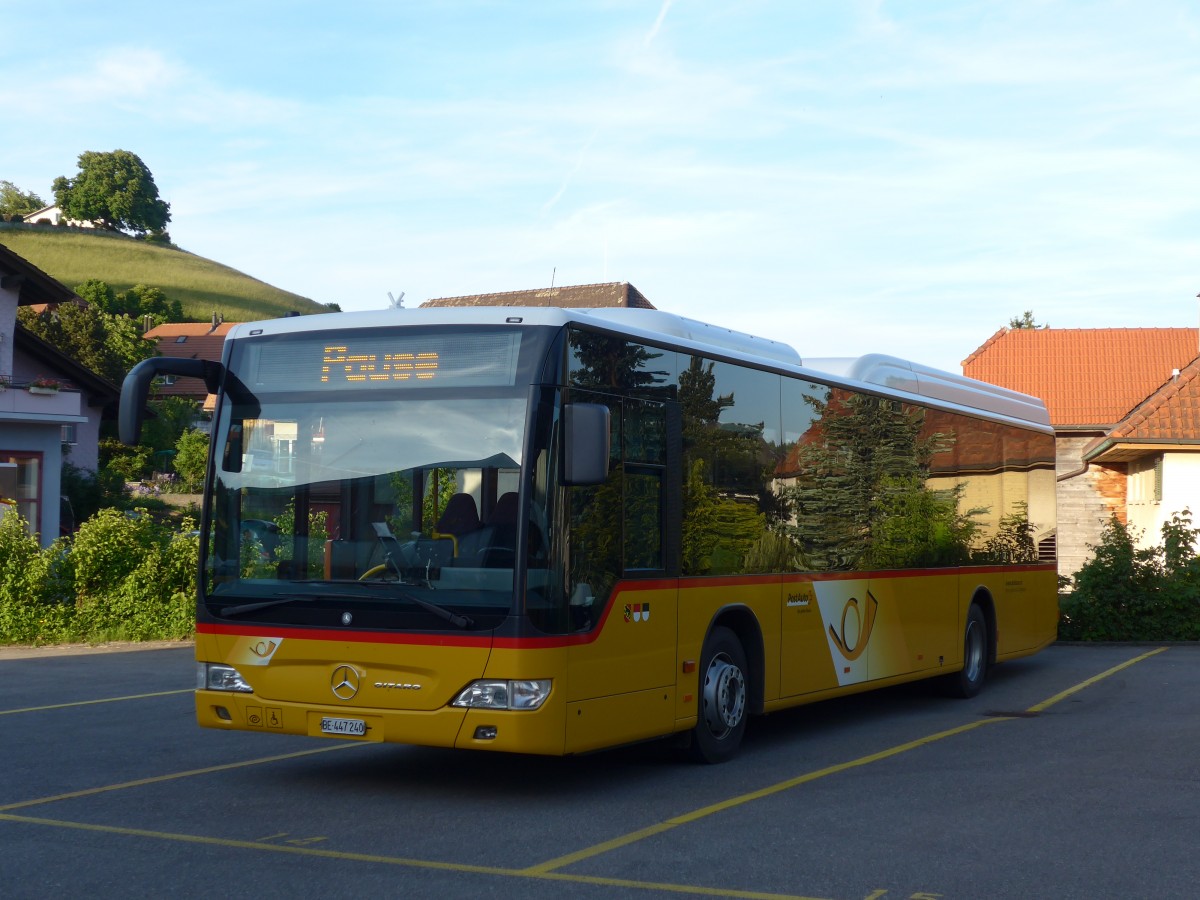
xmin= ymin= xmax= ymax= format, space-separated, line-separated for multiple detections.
xmin=0 ymin=245 xmax=120 ymax=546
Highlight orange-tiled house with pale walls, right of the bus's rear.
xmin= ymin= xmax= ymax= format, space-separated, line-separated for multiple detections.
xmin=962 ymin=328 xmax=1200 ymax=575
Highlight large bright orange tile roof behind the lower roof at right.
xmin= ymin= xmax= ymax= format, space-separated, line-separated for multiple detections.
xmin=962 ymin=328 xmax=1200 ymax=427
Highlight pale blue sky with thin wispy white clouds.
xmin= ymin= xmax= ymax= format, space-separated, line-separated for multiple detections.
xmin=0 ymin=0 xmax=1200 ymax=372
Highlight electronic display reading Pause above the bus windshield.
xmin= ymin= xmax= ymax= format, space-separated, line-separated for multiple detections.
xmin=242 ymin=331 xmax=521 ymax=391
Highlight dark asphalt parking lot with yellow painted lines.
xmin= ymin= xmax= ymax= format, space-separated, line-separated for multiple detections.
xmin=0 ymin=644 xmax=1200 ymax=900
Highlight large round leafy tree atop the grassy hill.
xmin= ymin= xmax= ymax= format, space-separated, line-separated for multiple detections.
xmin=54 ymin=150 xmax=170 ymax=238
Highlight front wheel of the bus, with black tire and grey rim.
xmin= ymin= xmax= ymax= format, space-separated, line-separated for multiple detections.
xmin=689 ymin=628 xmax=750 ymax=763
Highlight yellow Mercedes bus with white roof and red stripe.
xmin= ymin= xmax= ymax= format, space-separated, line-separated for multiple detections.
xmin=121 ymin=307 xmax=1057 ymax=762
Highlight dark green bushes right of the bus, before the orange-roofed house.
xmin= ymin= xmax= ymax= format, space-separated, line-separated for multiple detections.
xmin=1058 ymin=510 xmax=1200 ymax=641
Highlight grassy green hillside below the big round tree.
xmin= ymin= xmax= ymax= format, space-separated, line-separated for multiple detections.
xmin=0 ymin=224 xmax=329 ymax=322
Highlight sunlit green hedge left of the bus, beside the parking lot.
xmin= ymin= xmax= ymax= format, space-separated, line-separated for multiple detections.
xmin=0 ymin=509 xmax=199 ymax=643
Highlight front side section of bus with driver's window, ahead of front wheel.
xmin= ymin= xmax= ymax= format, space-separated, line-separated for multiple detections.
xmin=566 ymin=390 xmax=679 ymax=751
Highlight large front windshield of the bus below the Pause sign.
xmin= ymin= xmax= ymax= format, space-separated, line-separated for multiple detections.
xmin=204 ymin=328 xmax=542 ymax=629
